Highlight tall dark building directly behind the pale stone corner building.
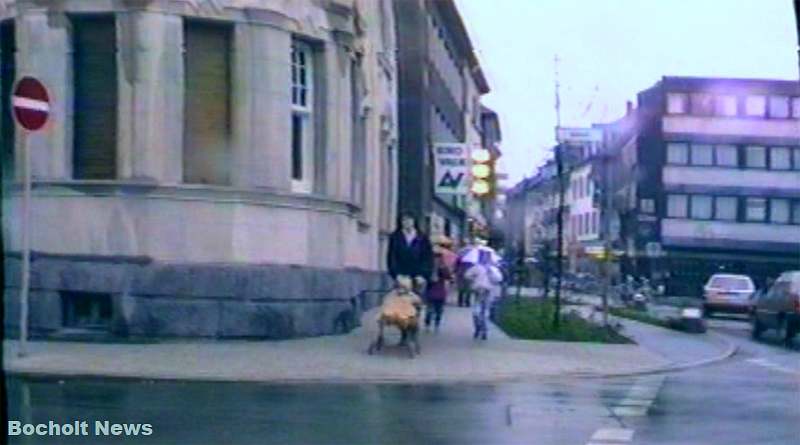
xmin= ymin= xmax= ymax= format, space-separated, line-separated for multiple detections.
xmin=394 ymin=0 xmax=489 ymax=238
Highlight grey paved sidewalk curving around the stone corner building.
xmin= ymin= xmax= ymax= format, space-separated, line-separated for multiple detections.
xmin=4 ymin=300 xmax=722 ymax=382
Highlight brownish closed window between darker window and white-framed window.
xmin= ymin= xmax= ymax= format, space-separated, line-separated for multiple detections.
xmin=183 ymin=20 xmax=232 ymax=185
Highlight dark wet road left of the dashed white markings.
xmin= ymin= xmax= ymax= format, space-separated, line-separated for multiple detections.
xmin=10 ymin=379 xmax=652 ymax=445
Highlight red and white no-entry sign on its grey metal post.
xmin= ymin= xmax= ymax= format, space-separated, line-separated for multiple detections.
xmin=11 ymin=77 xmax=50 ymax=357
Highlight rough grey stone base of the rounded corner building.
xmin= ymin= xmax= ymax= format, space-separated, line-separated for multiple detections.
xmin=4 ymin=257 xmax=389 ymax=339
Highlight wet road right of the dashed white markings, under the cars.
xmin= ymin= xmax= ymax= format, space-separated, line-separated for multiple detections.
xmin=628 ymin=317 xmax=800 ymax=445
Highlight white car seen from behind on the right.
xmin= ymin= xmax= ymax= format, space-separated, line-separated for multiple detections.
xmin=703 ymin=274 xmax=756 ymax=317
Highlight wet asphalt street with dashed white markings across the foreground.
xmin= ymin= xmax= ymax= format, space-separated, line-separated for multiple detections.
xmin=4 ymin=314 xmax=800 ymax=445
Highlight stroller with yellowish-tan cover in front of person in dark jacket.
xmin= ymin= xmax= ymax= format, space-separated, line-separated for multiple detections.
xmin=367 ymin=277 xmax=422 ymax=358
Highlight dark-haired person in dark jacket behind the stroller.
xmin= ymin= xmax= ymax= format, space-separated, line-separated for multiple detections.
xmin=386 ymin=212 xmax=433 ymax=343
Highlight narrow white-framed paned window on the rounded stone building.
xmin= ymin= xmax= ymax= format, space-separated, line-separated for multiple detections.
xmin=291 ymin=41 xmax=314 ymax=193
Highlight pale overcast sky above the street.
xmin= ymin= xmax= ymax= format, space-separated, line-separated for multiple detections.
xmin=456 ymin=0 xmax=798 ymax=185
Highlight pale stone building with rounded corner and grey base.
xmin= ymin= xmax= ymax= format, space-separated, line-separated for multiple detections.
xmin=0 ymin=0 xmax=397 ymax=338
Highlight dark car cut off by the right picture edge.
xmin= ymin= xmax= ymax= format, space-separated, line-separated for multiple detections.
xmin=751 ymin=270 xmax=800 ymax=344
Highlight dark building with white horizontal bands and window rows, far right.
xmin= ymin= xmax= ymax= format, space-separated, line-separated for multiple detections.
xmin=617 ymin=77 xmax=800 ymax=295
